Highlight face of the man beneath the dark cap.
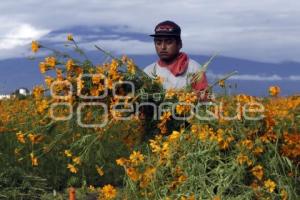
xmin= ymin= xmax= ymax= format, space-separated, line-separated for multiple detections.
xmin=154 ymin=37 xmax=181 ymax=62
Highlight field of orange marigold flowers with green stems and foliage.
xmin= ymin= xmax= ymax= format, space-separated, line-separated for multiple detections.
xmin=0 ymin=34 xmax=300 ymax=200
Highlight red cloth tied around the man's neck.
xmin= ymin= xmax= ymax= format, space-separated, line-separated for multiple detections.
xmin=158 ymin=52 xmax=189 ymax=76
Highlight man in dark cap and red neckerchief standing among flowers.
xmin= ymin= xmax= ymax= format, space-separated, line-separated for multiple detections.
xmin=144 ymin=21 xmax=208 ymax=92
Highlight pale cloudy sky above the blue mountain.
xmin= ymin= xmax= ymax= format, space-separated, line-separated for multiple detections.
xmin=0 ymin=0 xmax=300 ymax=62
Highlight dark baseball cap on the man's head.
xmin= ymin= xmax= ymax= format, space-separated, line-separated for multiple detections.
xmin=150 ymin=21 xmax=181 ymax=37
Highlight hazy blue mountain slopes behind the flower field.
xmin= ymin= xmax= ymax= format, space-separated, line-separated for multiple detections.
xmin=0 ymin=51 xmax=300 ymax=96
